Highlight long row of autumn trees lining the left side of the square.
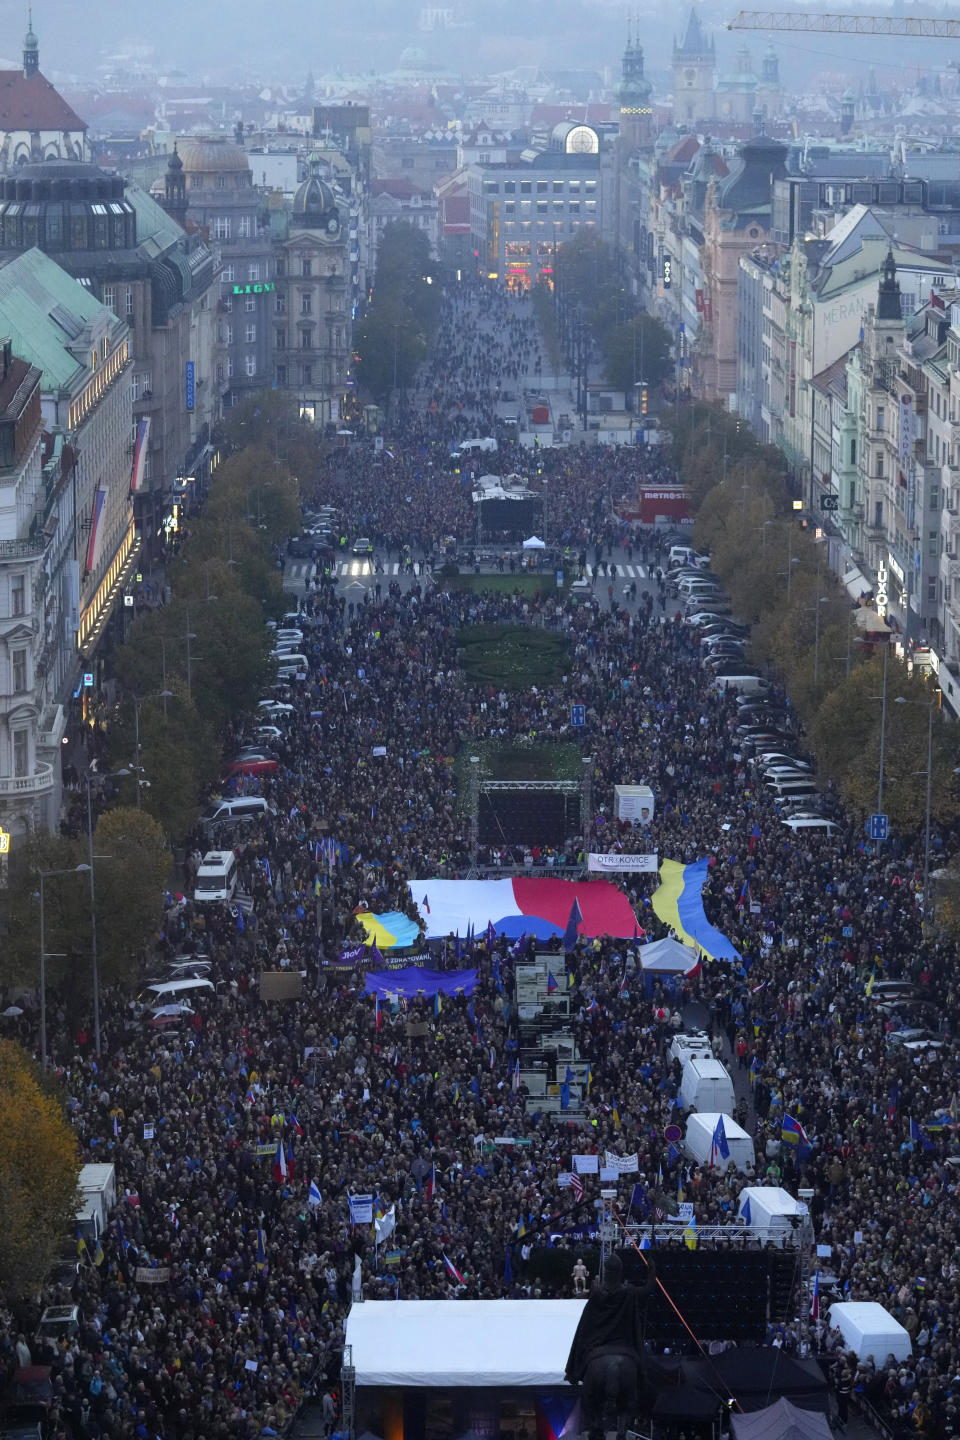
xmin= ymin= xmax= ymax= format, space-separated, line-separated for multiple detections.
xmin=0 ymin=392 xmax=318 ymax=1017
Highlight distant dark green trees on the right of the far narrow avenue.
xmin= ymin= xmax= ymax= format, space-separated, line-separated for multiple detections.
xmin=554 ymin=228 xmax=674 ymax=395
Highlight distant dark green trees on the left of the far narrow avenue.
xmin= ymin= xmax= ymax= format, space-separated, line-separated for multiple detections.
xmin=354 ymin=220 xmax=442 ymax=405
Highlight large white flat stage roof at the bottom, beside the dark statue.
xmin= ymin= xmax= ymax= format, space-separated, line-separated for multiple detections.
xmin=345 ymin=1300 xmax=586 ymax=1387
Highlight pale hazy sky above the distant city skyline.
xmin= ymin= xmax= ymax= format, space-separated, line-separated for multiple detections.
xmin=18 ymin=0 xmax=960 ymax=84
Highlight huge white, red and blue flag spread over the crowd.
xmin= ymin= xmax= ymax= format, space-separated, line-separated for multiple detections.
xmin=410 ymin=877 xmax=639 ymax=940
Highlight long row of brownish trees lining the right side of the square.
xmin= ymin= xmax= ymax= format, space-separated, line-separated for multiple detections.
xmin=674 ymin=406 xmax=957 ymax=835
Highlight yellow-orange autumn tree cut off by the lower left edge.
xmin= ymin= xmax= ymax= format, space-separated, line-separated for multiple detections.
xmin=0 ymin=1040 xmax=81 ymax=1305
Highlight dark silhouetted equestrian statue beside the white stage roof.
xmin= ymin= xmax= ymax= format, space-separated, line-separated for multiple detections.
xmin=566 ymin=1254 xmax=656 ymax=1440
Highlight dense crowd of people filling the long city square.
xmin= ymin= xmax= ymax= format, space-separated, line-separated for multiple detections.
xmin=3 ymin=289 xmax=960 ymax=1440
